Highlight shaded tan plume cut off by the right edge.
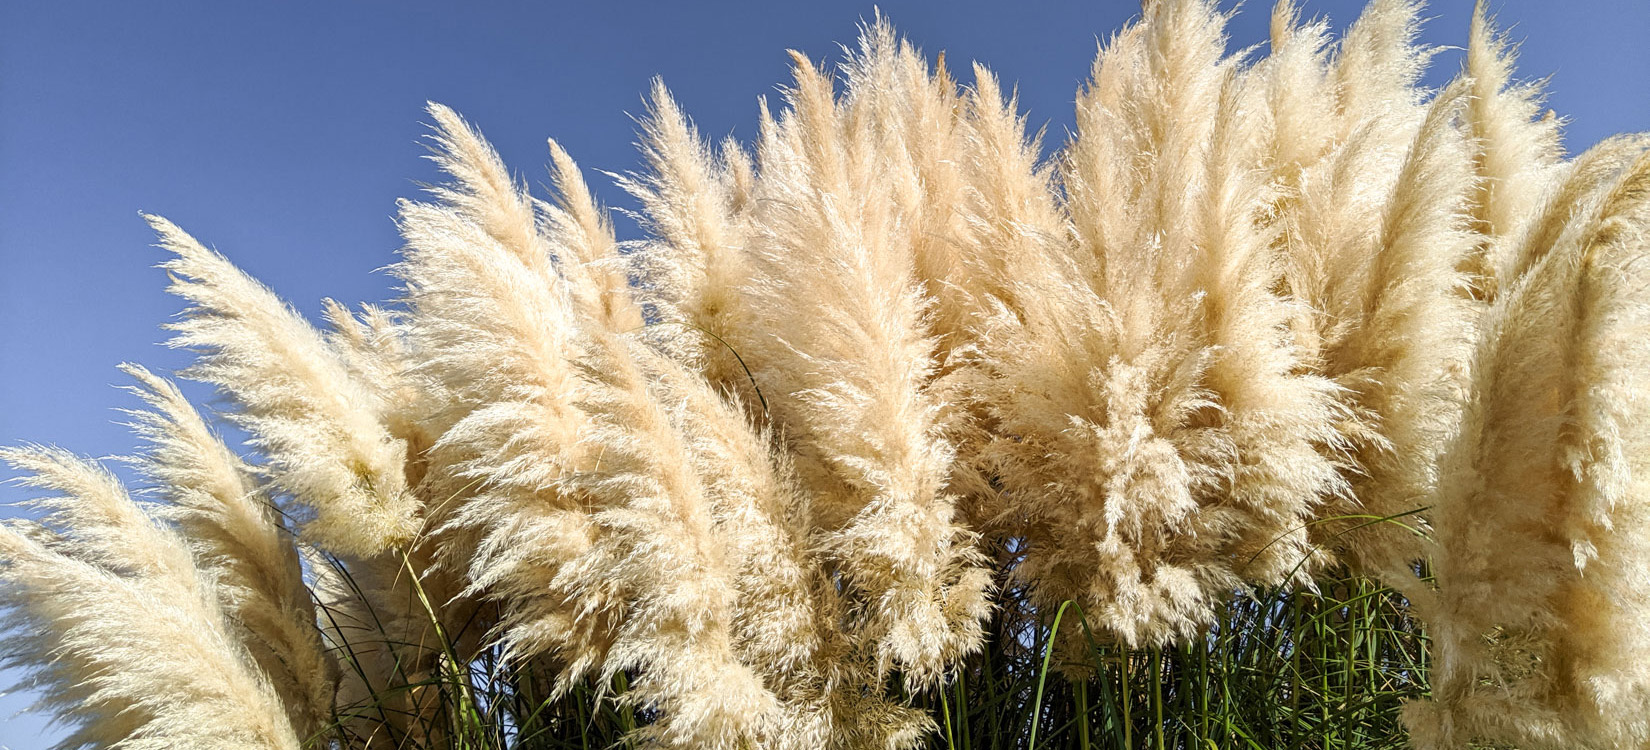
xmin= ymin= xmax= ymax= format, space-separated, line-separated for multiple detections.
xmin=1406 ymin=145 xmax=1650 ymax=748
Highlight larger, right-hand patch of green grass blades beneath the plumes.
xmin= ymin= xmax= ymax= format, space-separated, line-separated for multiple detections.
xmin=922 ymin=575 xmax=1427 ymax=750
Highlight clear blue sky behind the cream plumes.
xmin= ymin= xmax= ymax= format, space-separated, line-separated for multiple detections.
xmin=0 ymin=0 xmax=1650 ymax=750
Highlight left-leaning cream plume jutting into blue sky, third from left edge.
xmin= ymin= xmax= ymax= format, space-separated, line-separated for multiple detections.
xmin=149 ymin=216 xmax=419 ymax=555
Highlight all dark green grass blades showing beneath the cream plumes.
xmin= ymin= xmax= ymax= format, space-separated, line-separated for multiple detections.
xmin=315 ymin=574 xmax=1427 ymax=750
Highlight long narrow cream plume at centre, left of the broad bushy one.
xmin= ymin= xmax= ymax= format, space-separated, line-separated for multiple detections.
xmin=736 ymin=44 xmax=987 ymax=684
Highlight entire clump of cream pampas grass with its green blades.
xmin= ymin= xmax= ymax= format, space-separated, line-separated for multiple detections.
xmin=0 ymin=0 xmax=1650 ymax=750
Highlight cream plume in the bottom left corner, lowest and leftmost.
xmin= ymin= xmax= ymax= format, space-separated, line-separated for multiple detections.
xmin=0 ymin=448 xmax=300 ymax=750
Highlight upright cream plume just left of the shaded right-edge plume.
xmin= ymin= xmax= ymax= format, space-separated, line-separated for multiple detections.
xmin=1285 ymin=82 xmax=1475 ymax=598
